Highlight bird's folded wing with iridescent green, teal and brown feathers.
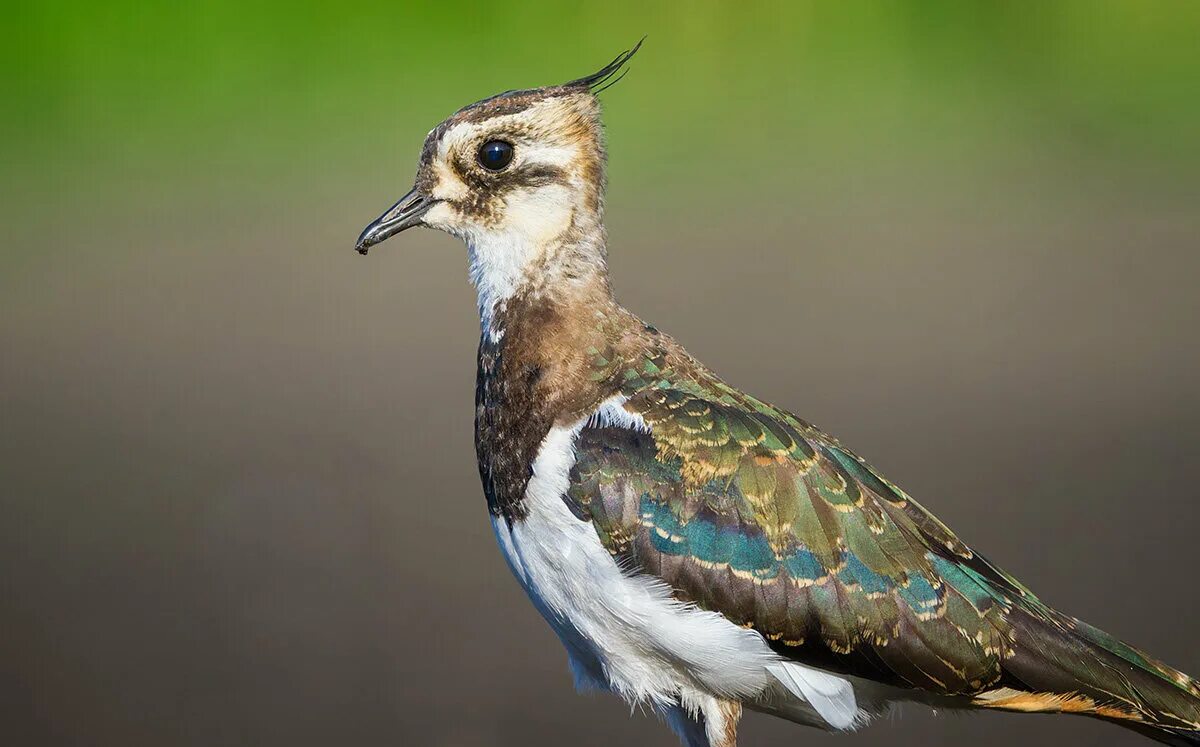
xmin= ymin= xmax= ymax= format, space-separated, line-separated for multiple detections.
xmin=568 ymin=345 xmax=1200 ymax=730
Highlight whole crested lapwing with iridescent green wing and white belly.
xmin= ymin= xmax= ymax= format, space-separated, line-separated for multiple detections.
xmin=355 ymin=42 xmax=1200 ymax=747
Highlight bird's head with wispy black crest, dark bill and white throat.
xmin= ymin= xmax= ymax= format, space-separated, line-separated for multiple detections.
xmin=355 ymin=42 xmax=641 ymax=321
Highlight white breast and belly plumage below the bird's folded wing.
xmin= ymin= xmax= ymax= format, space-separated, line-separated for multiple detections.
xmin=493 ymin=399 xmax=864 ymax=729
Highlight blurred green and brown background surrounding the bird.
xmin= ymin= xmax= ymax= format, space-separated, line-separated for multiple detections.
xmin=7 ymin=0 xmax=1200 ymax=746
